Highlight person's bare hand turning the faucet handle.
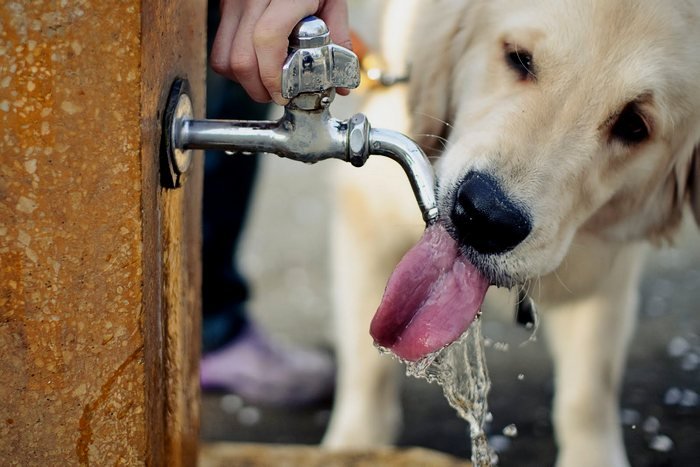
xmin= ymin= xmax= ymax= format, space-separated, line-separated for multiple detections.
xmin=210 ymin=0 xmax=352 ymax=105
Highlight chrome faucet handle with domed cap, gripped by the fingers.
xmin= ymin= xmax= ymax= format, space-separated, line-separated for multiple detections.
xmin=282 ymin=16 xmax=360 ymax=99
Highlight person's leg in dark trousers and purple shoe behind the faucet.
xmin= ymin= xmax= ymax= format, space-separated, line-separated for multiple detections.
xmin=200 ymin=2 xmax=334 ymax=405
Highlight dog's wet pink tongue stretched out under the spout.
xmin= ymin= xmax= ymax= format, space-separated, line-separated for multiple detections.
xmin=370 ymin=225 xmax=489 ymax=361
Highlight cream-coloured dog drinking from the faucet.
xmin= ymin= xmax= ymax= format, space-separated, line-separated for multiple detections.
xmin=324 ymin=0 xmax=700 ymax=467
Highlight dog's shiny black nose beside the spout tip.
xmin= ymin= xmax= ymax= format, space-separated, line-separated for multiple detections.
xmin=451 ymin=172 xmax=532 ymax=254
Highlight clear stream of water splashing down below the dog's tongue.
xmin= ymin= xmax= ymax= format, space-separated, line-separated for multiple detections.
xmin=384 ymin=319 xmax=497 ymax=467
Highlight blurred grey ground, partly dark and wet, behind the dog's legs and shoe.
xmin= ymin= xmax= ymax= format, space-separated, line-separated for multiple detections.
xmin=202 ymin=145 xmax=700 ymax=467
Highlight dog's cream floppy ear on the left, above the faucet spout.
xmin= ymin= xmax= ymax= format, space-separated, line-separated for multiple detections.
xmin=408 ymin=1 xmax=479 ymax=150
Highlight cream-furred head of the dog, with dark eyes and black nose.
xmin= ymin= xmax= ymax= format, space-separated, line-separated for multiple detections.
xmin=410 ymin=0 xmax=700 ymax=285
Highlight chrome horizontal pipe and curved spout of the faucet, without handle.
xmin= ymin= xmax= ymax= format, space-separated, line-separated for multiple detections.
xmin=173 ymin=108 xmax=438 ymax=225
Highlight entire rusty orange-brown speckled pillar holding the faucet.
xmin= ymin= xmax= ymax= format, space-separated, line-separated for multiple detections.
xmin=0 ymin=0 xmax=206 ymax=466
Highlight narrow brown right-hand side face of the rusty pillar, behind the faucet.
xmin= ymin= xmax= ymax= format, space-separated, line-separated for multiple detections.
xmin=141 ymin=0 xmax=207 ymax=467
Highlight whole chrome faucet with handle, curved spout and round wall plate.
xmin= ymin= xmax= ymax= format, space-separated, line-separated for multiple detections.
xmin=163 ymin=16 xmax=438 ymax=225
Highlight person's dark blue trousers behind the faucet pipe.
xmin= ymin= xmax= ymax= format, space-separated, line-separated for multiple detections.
xmin=202 ymin=2 xmax=267 ymax=352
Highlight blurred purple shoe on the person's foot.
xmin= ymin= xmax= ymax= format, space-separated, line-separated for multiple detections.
xmin=200 ymin=326 xmax=335 ymax=406
